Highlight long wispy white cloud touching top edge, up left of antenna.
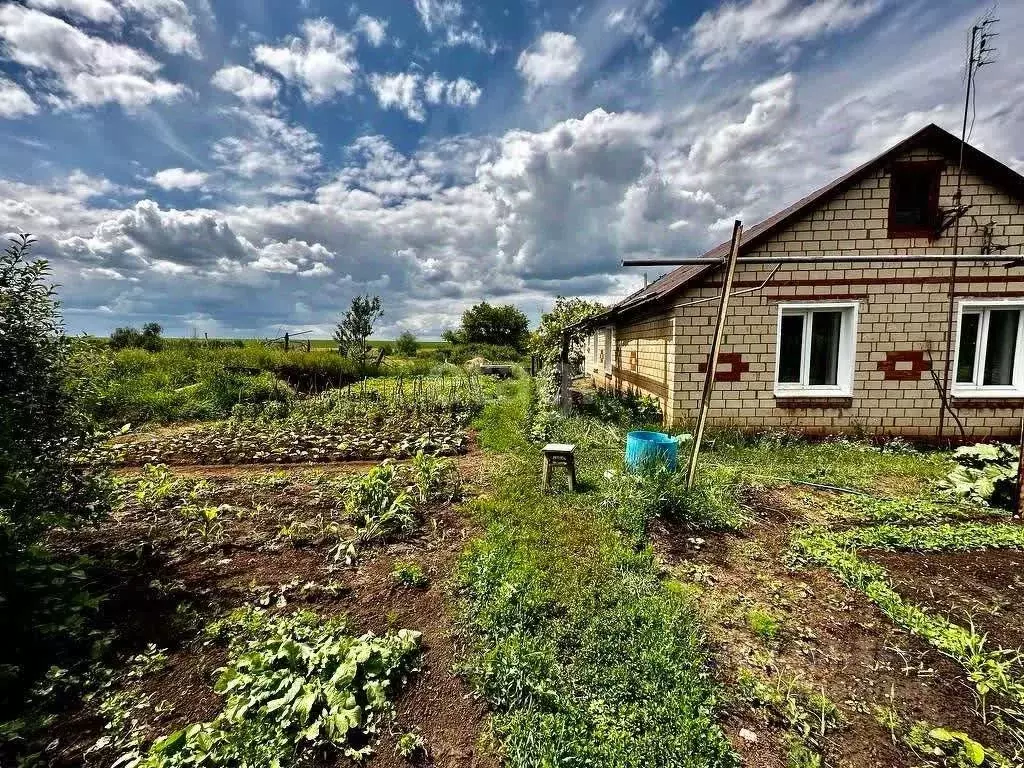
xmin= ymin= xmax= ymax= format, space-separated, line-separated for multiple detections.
xmin=691 ymin=0 xmax=883 ymax=69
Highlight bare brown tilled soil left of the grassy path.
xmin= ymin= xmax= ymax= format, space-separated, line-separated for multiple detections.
xmin=38 ymin=457 xmax=498 ymax=768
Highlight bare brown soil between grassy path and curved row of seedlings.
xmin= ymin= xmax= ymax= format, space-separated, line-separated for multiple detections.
xmin=652 ymin=495 xmax=1012 ymax=768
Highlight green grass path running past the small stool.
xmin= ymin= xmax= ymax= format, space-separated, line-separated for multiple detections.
xmin=458 ymin=379 xmax=736 ymax=767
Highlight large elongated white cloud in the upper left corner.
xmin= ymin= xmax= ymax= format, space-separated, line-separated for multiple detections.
xmin=0 ymin=5 xmax=185 ymax=109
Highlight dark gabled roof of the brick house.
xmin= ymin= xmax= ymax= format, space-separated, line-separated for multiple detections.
xmin=592 ymin=123 xmax=1024 ymax=321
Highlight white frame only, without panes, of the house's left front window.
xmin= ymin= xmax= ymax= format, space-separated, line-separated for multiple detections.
xmin=774 ymin=301 xmax=860 ymax=397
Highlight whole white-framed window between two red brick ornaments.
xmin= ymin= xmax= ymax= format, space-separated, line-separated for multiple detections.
xmin=775 ymin=302 xmax=857 ymax=397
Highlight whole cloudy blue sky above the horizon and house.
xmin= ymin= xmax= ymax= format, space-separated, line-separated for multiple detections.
xmin=0 ymin=0 xmax=1024 ymax=338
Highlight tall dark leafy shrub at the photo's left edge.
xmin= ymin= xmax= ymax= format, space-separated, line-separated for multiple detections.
xmin=0 ymin=237 xmax=108 ymax=720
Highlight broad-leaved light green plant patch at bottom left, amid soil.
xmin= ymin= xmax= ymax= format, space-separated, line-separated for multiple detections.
xmin=130 ymin=612 xmax=420 ymax=768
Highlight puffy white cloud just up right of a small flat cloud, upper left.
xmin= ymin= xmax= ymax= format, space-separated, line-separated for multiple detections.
xmin=253 ymin=18 xmax=358 ymax=103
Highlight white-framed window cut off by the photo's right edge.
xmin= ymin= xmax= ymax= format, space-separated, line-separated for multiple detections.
xmin=953 ymin=301 xmax=1024 ymax=397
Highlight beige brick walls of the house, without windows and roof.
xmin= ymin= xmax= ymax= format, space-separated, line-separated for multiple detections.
xmin=598 ymin=151 xmax=1024 ymax=438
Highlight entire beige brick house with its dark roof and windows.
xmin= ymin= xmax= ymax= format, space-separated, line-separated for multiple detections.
xmin=585 ymin=125 xmax=1024 ymax=440
